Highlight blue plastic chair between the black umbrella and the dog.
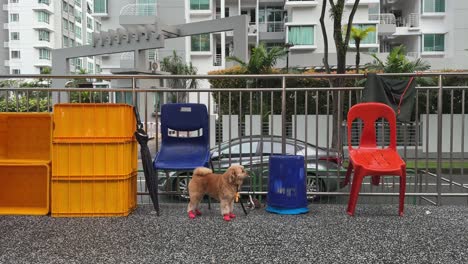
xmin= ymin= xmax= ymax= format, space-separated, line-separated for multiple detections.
xmin=153 ymin=103 xmax=212 ymax=207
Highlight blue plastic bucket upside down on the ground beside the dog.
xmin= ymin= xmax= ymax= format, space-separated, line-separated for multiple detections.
xmin=266 ymin=155 xmax=309 ymax=214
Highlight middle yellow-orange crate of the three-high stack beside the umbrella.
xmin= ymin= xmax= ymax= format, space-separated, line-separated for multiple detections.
xmin=52 ymin=141 xmax=138 ymax=178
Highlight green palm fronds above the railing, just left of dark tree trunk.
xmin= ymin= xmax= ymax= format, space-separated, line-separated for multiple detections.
xmin=227 ymin=43 xmax=287 ymax=74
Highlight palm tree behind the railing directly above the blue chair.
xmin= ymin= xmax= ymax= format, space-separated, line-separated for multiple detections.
xmin=161 ymin=50 xmax=198 ymax=102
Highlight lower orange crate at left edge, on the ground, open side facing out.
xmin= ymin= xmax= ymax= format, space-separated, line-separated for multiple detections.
xmin=0 ymin=163 xmax=50 ymax=215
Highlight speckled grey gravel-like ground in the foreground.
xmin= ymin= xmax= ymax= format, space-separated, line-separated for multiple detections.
xmin=0 ymin=204 xmax=468 ymax=264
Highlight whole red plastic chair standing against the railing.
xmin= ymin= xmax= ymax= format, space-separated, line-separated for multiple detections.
xmin=344 ymin=103 xmax=406 ymax=216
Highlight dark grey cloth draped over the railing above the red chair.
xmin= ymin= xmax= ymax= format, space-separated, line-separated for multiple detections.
xmin=362 ymin=73 xmax=416 ymax=122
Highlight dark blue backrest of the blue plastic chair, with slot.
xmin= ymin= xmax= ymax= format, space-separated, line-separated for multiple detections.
xmin=161 ymin=103 xmax=210 ymax=145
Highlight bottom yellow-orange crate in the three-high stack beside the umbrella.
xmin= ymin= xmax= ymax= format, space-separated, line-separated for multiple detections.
xmin=51 ymin=173 xmax=137 ymax=217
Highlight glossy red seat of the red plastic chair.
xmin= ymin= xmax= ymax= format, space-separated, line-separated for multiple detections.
xmin=349 ymin=148 xmax=405 ymax=175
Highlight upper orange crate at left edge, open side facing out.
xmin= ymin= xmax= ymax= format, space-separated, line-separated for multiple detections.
xmin=0 ymin=113 xmax=52 ymax=163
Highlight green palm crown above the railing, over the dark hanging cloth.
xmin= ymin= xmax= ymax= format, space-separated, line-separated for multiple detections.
xmin=366 ymin=45 xmax=431 ymax=73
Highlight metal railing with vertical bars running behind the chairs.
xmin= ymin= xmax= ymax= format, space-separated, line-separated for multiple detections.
xmin=0 ymin=72 xmax=468 ymax=204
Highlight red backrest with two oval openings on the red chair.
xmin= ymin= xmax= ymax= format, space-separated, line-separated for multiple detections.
xmin=347 ymin=103 xmax=396 ymax=150
